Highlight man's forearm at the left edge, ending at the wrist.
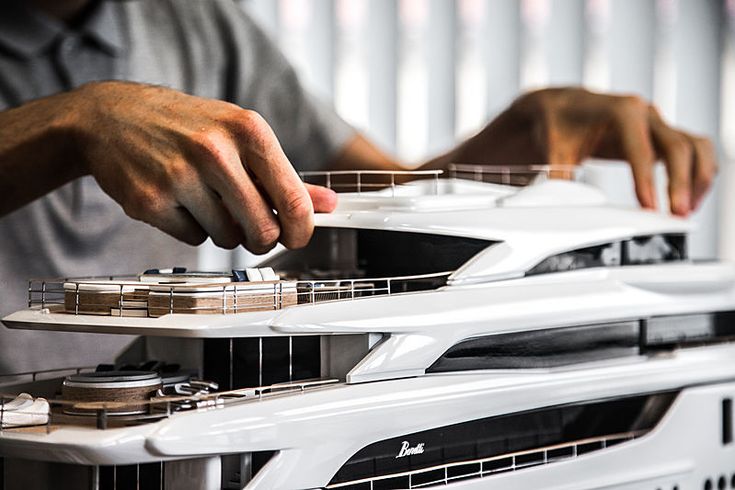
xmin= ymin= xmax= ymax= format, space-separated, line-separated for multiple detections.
xmin=0 ymin=93 xmax=84 ymax=216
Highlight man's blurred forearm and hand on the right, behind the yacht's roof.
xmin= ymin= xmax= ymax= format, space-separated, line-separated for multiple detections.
xmin=428 ymin=88 xmax=717 ymax=216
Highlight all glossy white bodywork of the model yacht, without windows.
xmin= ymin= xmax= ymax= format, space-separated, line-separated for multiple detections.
xmin=0 ymin=181 xmax=735 ymax=490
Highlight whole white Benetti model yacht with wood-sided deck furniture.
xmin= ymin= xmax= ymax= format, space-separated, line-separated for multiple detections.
xmin=0 ymin=166 xmax=735 ymax=490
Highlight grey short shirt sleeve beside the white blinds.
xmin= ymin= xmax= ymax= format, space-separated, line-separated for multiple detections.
xmin=211 ymin=0 xmax=355 ymax=171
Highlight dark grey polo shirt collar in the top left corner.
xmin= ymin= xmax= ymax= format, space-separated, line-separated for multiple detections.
xmin=0 ymin=0 xmax=125 ymax=59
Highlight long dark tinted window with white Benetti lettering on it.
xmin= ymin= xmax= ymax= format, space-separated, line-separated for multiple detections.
xmin=330 ymin=393 xmax=675 ymax=488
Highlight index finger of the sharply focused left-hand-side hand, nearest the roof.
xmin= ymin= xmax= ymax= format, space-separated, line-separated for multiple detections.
xmin=233 ymin=111 xmax=314 ymax=248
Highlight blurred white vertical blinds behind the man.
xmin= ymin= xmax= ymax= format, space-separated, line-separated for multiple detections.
xmin=201 ymin=0 xmax=735 ymax=269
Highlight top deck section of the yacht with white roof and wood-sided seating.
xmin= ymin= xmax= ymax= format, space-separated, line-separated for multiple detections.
xmin=4 ymin=167 xmax=690 ymax=336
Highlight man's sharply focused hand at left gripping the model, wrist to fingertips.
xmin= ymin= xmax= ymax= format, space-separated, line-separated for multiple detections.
xmin=70 ymin=82 xmax=336 ymax=253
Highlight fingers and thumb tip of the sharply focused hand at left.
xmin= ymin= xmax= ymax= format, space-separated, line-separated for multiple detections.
xmin=188 ymin=111 xmax=336 ymax=253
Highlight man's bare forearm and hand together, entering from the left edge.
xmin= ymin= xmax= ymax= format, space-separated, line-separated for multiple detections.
xmin=0 ymin=82 xmax=336 ymax=253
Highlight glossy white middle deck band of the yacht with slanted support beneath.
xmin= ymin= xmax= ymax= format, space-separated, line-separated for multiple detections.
xmin=5 ymin=263 xmax=735 ymax=383
